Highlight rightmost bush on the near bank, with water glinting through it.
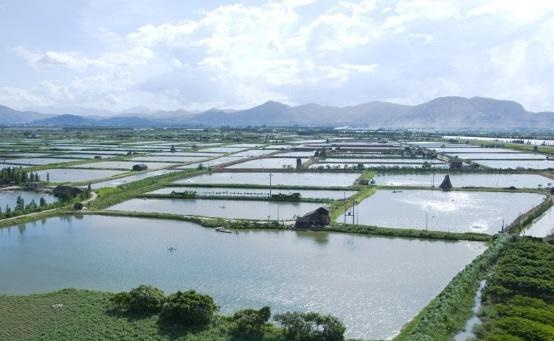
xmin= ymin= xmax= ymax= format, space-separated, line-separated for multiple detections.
xmin=275 ymin=312 xmax=346 ymax=341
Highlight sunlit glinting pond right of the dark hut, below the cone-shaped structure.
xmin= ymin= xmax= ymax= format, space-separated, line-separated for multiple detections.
xmin=337 ymin=190 xmax=544 ymax=234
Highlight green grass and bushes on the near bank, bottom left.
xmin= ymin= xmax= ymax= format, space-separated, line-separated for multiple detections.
xmin=0 ymin=286 xmax=345 ymax=341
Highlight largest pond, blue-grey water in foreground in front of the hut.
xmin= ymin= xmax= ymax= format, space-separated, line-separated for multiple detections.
xmin=0 ymin=216 xmax=485 ymax=339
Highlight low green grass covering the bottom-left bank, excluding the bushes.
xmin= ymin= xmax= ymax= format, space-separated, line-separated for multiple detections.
xmin=0 ymin=289 xmax=285 ymax=341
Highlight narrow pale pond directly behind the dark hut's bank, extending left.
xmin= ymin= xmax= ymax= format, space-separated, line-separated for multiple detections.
xmin=108 ymin=199 xmax=322 ymax=220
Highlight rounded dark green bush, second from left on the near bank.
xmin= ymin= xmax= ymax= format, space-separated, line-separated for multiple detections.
xmin=160 ymin=290 xmax=218 ymax=326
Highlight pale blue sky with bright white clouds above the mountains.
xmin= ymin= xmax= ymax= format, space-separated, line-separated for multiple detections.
xmin=0 ymin=0 xmax=554 ymax=114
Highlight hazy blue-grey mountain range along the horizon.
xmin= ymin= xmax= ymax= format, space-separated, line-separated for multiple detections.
xmin=0 ymin=97 xmax=554 ymax=129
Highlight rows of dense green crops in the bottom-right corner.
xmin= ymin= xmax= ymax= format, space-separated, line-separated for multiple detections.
xmin=476 ymin=237 xmax=554 ymax=341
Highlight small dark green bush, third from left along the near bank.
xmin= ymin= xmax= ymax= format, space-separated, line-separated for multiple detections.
xmin=229 ymin=307 xmax=271 ymax=341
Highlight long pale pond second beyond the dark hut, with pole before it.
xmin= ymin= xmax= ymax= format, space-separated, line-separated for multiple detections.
xmin=176 ymin=172 xmax=360 ymax=187
